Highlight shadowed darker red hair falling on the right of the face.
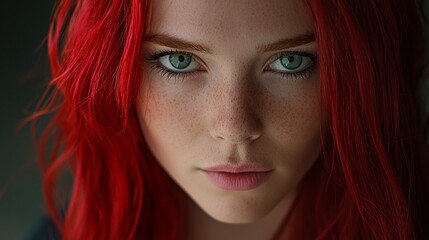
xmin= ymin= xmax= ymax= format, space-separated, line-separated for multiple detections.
xmin=280 ymin=0 xmax=429 ymax=240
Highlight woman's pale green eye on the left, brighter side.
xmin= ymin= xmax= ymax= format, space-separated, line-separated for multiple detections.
xmin=159 ymin=52 xmax=200 ymax=72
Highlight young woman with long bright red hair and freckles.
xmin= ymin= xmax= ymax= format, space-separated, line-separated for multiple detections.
xmin=31 ymin=0 xmax=429 ymax=239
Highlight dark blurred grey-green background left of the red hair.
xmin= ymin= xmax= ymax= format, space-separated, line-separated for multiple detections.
xmin=0 ymin=0 xmax=429 ymax=240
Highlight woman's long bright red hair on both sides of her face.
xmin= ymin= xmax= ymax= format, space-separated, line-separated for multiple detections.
xmin=31 ymin=0 xmax=429 ymax=240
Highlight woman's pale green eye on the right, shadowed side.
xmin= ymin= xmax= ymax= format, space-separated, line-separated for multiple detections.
xmin=269 ymin=53 xmax=314 ymax=73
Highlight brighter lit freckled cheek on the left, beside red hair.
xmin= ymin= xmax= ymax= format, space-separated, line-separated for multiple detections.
xmin=137 ymin=79 xmax=201 ymax=166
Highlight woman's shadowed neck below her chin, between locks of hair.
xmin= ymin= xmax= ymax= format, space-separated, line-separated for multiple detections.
xmin=186 ymin=189 xmax=296 ymax=240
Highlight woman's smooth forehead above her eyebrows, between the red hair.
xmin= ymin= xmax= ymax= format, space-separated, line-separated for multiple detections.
xmin=148 ymin=0 xmax=313 ymax=50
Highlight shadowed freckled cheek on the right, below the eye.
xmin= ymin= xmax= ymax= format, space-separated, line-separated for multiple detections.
xmin=265 ymin=79 xmax=323 ymax=175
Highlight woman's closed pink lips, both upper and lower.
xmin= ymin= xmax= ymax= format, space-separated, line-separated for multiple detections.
xmin=202 ymin=164 xmax=273 ymax=191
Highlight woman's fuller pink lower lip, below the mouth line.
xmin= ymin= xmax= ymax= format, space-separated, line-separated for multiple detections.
xmin=204 ymin=171 xmax=271 ymax=191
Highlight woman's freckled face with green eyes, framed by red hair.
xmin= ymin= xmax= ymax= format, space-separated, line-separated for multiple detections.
xmin=137 ymin=0 xmax=322 ymax=223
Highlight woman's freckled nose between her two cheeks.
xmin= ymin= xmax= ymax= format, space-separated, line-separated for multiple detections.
xmin=208 ymin=74 xmax=262 ymax=144
